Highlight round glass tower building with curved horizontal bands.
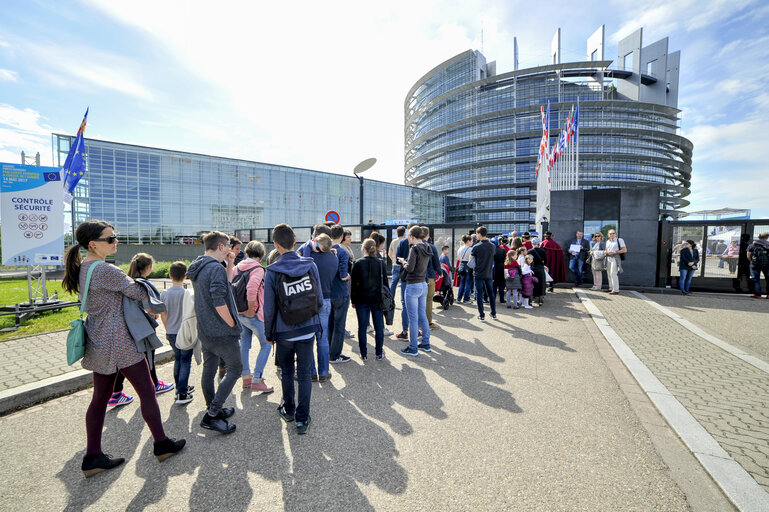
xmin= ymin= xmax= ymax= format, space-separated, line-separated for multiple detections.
xmin=404 ymin=26 xmax=693 ymax=232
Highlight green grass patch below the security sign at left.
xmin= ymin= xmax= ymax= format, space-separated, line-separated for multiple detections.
xmin=0 ymin=279 xmax=80 ymax=340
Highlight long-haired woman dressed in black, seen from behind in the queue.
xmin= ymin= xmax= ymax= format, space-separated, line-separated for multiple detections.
xmin=350 ymin=238 xmax=387 ymax=362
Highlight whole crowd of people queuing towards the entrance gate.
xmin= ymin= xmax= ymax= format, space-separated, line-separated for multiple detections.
xmin=64 ymin=216 xmax=640 ymax=476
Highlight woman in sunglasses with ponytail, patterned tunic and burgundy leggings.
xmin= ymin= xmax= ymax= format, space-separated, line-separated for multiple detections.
xmin=62 ymin=220 xmax=185 ymax=477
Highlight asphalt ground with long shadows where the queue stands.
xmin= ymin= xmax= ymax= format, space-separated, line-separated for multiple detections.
xmin=0 ymin=290 xmax=712 ymax=511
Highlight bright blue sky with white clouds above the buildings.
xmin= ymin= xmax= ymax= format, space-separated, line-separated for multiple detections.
xmin=0 ymin=0 xmax=769 ymax=218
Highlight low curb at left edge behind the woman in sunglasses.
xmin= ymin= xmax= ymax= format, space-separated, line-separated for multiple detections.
xmin=0 ymin=345 xmax=174 ymax=416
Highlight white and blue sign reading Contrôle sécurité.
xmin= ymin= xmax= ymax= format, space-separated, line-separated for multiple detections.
xmin=0 ymin=162 xmax=64 ymax=265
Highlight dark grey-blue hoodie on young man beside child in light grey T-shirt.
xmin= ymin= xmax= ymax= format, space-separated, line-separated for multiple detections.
xmin=187 ymin=255 xmax=242 ymax=338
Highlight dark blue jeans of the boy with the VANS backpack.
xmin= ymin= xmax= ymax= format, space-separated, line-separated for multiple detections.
xmin=276 ymin=336 xmax=314 ymax=421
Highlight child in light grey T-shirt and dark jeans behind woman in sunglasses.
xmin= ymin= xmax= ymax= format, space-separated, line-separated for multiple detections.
xmin=160 ymin=261 xmax=194 ymax=405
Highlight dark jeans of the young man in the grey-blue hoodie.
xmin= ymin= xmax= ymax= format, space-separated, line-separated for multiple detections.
xmin=198 ymin=331 xmax=243 ymax=416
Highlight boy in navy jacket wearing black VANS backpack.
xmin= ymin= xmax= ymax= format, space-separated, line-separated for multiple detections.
xmin=264 ymin=224 xmax=323 ymax=434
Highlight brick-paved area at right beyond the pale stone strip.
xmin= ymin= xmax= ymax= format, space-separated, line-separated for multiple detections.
xmin=586 ymin=292 xmax=769 ymax=491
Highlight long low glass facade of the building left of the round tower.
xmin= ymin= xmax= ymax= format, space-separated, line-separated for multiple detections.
xmin=53 ymin=134 xmax=445 ymax=243
